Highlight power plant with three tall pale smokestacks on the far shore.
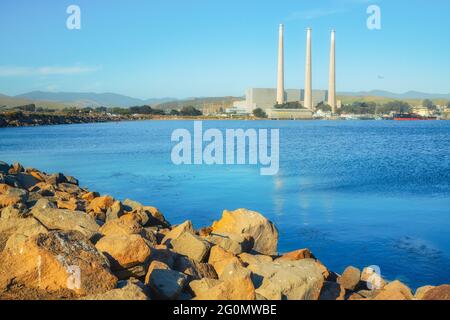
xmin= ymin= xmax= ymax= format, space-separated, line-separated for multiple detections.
xmin=227 ymin=24 xmax=338 ymax=119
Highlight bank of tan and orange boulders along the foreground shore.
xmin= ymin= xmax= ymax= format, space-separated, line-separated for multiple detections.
xmin=0 ymin=162 xmax=450 ymax=300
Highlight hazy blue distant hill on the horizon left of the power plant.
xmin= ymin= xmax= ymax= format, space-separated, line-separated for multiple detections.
xmin=14 ymin=91 xmax=176 ymax=107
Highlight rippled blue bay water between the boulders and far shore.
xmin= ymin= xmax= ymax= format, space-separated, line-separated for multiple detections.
xmin=0 ymin=121 xmax=450 ymax=288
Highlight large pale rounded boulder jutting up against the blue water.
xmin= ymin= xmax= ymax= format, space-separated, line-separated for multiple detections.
xmin=212 ymin=209 xmax=278 ymax=255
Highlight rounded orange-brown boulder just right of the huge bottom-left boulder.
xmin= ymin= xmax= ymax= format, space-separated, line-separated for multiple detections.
xmin=95 ymin=234 xmax=151 ymax=270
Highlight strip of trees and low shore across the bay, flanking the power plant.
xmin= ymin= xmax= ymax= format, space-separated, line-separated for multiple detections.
xmin=0 ymin=101 xmax=450 ymax=128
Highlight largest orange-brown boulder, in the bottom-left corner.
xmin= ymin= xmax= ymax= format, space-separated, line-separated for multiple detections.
xmin=0 ymin=231 xmax=117 ymax=295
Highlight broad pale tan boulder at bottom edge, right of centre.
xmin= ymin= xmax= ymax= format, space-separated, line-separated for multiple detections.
xmin=247 ymin=259 xmax=324 ymax=300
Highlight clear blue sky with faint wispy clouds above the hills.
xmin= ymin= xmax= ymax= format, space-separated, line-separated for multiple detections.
xmin=0 ymin=0 xmax=450 ymax=98
